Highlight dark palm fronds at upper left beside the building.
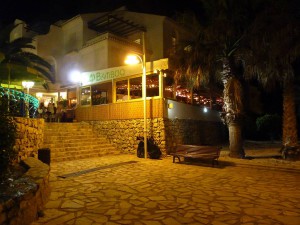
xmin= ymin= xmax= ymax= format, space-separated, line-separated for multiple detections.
xmin=0 ymin=24 xmax=55 ymax=88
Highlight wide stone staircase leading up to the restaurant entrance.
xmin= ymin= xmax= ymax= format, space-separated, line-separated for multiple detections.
xmin=43 ymin=122 xmax=120 ymax=162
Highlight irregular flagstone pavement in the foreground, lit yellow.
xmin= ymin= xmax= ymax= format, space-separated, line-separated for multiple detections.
xmin=32 ymin=155 xmax=300 ymax=225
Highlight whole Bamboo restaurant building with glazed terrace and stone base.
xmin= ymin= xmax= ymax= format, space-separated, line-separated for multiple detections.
xmin=18 ymin=8 xmax=224 ymax=153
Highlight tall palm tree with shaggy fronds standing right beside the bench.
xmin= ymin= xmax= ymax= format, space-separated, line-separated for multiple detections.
xmin=173 ymin=0 xmax=257 ymax=158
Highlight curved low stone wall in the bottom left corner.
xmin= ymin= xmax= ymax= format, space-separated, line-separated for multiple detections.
xmin=0 ymin=157 xmax=50 ymax=225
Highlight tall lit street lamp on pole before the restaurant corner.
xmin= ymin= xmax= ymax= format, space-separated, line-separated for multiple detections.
xmin=125 ymin=32 xmax=148 ymax=159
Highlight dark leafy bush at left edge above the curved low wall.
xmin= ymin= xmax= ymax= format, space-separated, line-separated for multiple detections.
xmin=0 ymin=98 xmax=17 ymax=178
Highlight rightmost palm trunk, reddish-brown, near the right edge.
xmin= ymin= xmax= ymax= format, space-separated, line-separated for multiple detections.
xmin=282 ymin=82 xmax=298 ymax=146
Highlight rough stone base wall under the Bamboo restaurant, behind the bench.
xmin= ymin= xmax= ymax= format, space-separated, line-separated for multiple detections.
xmin=89 ymin=118 xmax=226 ymax=155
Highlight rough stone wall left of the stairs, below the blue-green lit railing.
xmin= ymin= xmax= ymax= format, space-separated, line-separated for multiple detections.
xmin=14 ymin=117 xmax=44 ymax=162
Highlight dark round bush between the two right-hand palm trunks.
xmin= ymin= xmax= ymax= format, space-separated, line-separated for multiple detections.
xmin=256 ymin=114 xmax=282 ymax=140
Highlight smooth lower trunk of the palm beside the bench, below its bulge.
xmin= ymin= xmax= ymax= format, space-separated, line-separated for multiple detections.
xmin=228 ymin=122 xmax=245 ymax=158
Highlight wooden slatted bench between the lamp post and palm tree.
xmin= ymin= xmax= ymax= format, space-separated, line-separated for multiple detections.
xmin=170 ymin=145 xmax=222 ymax=166
